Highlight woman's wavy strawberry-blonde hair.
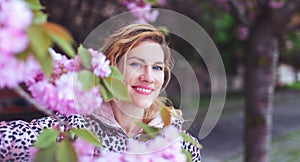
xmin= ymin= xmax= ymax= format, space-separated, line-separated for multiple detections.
xmin=100 ymin=24 xmax=178 ymax=123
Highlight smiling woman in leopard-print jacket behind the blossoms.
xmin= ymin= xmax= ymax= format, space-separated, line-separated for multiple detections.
xmin=0 ymin=24 xmax=200 ymax=161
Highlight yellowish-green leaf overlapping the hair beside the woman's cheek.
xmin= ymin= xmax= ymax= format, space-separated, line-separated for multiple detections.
xmin=102 ymin=76 xmax=131 ymax=101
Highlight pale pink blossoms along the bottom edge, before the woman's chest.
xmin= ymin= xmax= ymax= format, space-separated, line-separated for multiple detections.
xmin=73 ymin=126 xmax=187 ymax=162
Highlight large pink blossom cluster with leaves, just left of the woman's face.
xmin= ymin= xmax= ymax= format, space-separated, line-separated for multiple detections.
xmin=28 ymin=49 xmax=111 ymax=116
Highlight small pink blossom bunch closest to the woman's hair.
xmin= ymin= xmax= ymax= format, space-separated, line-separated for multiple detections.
xmin=88 ymin=48 xmax=111 ymax=78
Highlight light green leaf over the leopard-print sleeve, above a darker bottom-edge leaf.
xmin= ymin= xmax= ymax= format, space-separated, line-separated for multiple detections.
xmin=34 ymin=129 xmax=59 ymax=148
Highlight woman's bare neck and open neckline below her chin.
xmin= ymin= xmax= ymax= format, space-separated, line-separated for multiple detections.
xmin=111 ymin=101 xmax=144 ymax=137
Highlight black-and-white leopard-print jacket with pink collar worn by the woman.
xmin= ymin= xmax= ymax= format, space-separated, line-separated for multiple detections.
xmin=0 ymin=103 xmax=201 ymax=162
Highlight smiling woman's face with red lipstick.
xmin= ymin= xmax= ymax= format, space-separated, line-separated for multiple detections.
xmin=118 ymin=41 xmax=164 ymax=108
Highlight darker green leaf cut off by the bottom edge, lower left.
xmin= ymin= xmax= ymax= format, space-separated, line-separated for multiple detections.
xmin=34 ymin=143 xmax=57 ymax=162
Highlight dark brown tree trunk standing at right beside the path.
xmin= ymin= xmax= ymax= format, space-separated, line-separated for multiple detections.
xmin=244 ymin=10 xmax=279 ymax=162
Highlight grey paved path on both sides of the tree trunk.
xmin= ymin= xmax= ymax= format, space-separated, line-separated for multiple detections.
xmin=201 ymin=91 xmax=300 ymax=162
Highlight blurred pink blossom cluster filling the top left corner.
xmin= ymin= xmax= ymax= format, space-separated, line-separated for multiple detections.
xmin=0 ymin=0 xmax=39 ymax=89
